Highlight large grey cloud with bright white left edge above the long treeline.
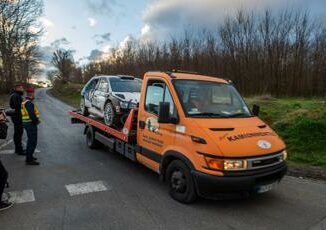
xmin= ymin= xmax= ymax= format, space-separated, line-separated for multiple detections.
xmin=141 ymin=0 xmax=326 ymax=40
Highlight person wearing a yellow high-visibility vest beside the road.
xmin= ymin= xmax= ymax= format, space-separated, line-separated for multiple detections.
xmin=21 ymin=88 xmax=40 ymax=165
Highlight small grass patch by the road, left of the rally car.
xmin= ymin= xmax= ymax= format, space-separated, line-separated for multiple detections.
xmin=50 ymin=83 xmax=83 ymax=108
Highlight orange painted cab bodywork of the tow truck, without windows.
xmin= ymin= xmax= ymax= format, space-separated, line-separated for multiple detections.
xmin=137 ymin=72 xmax=285 ymax=176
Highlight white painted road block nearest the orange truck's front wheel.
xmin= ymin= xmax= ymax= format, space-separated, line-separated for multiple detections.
xmin=66 ymin=181 xmax=109 ymax=196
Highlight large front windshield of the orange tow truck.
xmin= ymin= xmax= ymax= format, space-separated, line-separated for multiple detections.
xmin=174 ymin=80 xmax=251 ymax=117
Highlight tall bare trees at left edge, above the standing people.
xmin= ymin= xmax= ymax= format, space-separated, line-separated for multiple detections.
xmin=0 ymin=0 xmax=43 ymax=93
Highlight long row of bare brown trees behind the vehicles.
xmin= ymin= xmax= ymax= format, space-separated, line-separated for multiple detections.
xmin=82 ymin=10 xmax=326 ymax=96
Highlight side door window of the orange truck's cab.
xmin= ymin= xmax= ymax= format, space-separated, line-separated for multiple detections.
xmin=145 ymin=80 xmax=175 ymax=116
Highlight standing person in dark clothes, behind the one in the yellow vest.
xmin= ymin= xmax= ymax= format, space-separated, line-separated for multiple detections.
xmin=9 ymin=84 xmax=26 ymax=155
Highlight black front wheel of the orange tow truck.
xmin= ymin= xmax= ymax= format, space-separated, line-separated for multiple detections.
xmin=166 ymin=160 xmax=197 ymax=204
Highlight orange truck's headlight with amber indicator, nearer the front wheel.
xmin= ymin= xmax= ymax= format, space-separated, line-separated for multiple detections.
xmin=205 ymin=156 xmax=247 ymax=171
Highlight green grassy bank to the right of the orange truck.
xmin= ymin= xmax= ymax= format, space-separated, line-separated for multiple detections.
xmin=246 ymin=98 xmax=326 ymax=167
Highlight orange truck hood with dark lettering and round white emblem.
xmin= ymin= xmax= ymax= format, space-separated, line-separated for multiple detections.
xmin=196 ymin=117 xmax=285 ymax=157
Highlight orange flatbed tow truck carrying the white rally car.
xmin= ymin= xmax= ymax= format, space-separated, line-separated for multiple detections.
xmin=70 ymin=72 xmax=287 ymax=203
